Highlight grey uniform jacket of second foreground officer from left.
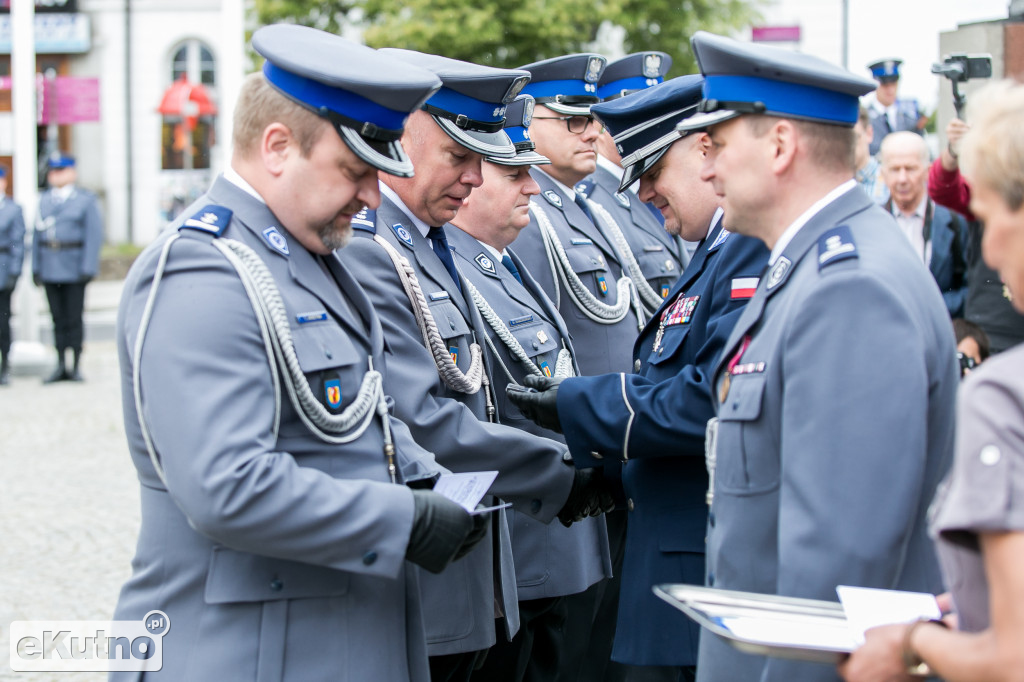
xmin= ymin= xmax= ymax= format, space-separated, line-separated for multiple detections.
xmin=338 ymin=197 xmax=572 ymax=655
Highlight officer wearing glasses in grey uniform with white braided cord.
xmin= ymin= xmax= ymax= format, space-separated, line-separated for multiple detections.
xmin=515 ymin=53 xmax=645 ymax=680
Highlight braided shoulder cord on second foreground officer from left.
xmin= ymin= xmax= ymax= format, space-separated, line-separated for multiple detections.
xmin=374 ymin=235 xmax=489 ymax=399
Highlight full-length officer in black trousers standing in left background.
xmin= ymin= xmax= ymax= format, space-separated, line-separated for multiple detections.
xmin=32 ymin=155 xmax=103 ymax=383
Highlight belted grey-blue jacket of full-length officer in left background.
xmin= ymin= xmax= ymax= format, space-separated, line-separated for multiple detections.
xmin=32 ymin=187 xmax=103 ymax=284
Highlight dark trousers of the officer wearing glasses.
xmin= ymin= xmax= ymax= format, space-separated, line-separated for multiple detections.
xmin=562 ymin=510 xmax=628 ymax=682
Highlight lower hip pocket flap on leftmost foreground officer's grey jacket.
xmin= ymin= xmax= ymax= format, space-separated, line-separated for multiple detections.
xmin=204 ymin=547 xmax=349 ymax=604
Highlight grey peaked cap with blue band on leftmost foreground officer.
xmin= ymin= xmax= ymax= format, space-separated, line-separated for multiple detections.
xmin=252 ymin=24 xmax=440 ymax=177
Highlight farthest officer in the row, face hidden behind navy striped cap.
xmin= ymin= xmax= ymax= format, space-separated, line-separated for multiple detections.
xmin=575 ymin=52 xmax=689 ymax=309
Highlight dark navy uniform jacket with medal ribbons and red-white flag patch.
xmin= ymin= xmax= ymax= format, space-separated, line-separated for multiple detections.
xmin=558 ymin=220 xmax=768 ymax=666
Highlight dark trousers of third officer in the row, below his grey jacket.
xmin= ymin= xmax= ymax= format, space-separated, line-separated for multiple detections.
xmin=472 ymin=597 xmax=568 ymax=682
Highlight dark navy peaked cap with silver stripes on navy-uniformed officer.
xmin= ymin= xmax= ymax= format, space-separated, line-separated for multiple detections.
xmin=591 ymin=75 xmax=703 ymax=191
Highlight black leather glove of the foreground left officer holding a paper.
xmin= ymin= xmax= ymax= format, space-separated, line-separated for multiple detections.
xmin=406 ymin=489 xmax=489 ymax=573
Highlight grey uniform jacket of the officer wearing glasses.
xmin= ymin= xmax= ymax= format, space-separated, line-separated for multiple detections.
xmin=513 ymin=168 xmax=643 ymax=375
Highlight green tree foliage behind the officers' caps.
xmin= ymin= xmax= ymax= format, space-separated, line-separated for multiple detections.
xmin=256 ymin=0 xmax=767 ymax=76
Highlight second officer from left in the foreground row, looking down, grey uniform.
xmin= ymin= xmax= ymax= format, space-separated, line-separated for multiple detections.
xmin=339 ymin=49 xmax=610 ymax=682
